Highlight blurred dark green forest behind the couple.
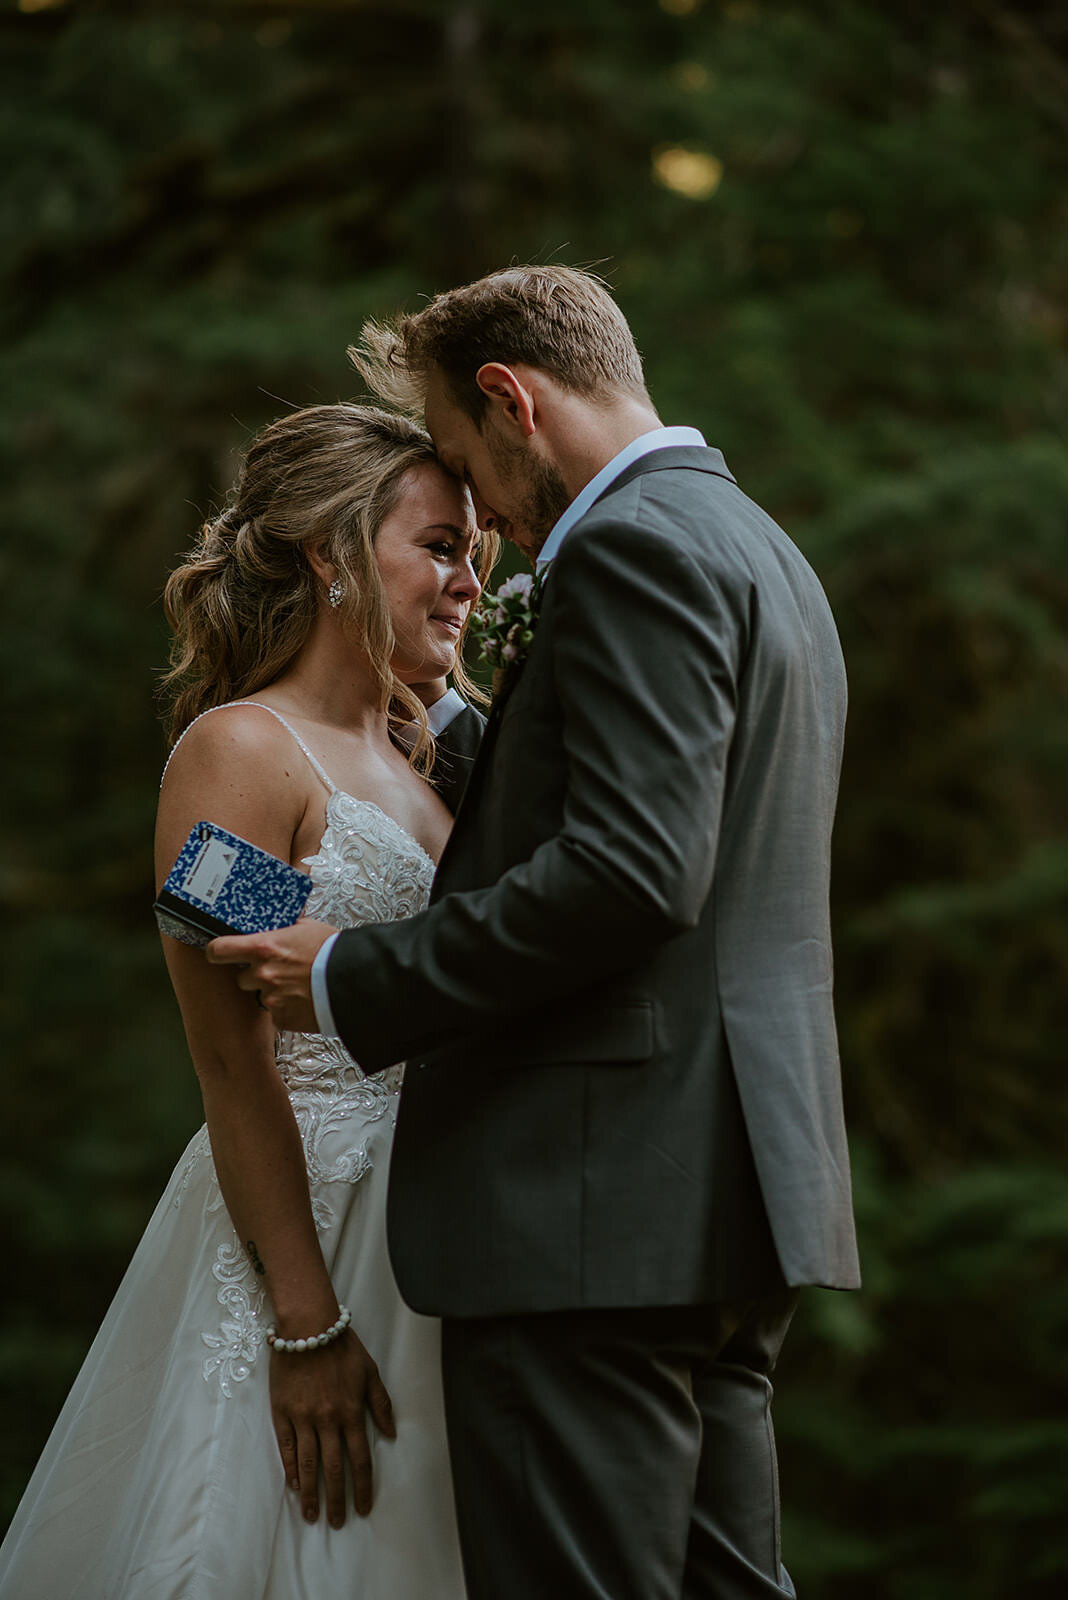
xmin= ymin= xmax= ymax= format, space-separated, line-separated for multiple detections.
xmin=0 ymin=0 xmax=1068 ymax=1600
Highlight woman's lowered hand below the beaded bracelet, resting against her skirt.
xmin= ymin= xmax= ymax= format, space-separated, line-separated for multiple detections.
xmin=270 ymin=1328 xmax=397 ymax=1528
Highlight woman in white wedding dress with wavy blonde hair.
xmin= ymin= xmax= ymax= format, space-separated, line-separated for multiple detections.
xmin=0 ymin=405 xmax=480 ymax=1600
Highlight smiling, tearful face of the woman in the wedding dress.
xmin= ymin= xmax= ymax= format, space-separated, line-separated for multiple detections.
xmin=374 ymin=462 xmax=480 ymax=683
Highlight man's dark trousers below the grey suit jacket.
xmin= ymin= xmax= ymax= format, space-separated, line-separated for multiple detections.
xmin=443 ymin=1291 xmax=796 ymax=1600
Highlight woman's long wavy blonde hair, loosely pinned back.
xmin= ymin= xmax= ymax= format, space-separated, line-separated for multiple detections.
xmin=160 ymin=405 xmax=497 ymax=773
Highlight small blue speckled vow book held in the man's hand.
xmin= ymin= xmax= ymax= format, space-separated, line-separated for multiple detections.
xmin=152 ymin=822 xmax=312 ymax=946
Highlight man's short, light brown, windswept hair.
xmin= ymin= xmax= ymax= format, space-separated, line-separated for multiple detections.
xmin=349 ymin=267 xmax=648 ymax=426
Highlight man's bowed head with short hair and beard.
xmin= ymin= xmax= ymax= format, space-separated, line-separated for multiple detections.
xmin=350 ymin=267 xmax=656 ymax=554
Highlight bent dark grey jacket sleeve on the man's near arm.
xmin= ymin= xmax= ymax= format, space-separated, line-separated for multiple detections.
xmin=328 ymin=520 xmax=747 ymax=1072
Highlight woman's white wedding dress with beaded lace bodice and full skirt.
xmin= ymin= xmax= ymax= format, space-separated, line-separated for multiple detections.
xmin=0 ymin=707 xmax=464 ymax=1600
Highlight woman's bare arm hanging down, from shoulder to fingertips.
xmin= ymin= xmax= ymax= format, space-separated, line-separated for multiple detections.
xmin=155 ymin=709 xmax=393 ymax=1525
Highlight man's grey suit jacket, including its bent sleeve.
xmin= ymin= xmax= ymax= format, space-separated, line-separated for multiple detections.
xmin=328 ymin=448 xmax=859 ymax=1315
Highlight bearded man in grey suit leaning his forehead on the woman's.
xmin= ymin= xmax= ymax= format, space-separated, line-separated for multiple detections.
xmin=217 ymin=267 xmax=859 ymax=1600
